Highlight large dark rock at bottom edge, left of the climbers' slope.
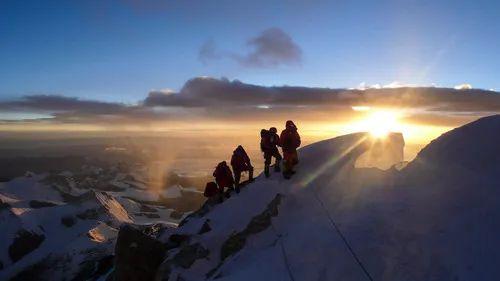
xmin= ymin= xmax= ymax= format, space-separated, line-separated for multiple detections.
xmin=114 ymin=225 xmax=166 ymax=281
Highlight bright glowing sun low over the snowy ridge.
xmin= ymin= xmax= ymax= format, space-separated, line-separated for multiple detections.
xmin=353 ymin=109 xmax=402 ymax=138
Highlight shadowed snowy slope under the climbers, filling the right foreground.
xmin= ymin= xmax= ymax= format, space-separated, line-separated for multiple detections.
xmin=158 ymin=115 xmax=500 ymax=281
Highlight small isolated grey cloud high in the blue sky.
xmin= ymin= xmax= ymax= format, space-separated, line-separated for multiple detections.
xmin=198 ymin=28 xmax=302 ymax=68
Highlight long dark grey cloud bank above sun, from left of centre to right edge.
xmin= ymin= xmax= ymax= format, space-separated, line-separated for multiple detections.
xmin=145 ymin=77 xmax=500 ymax=112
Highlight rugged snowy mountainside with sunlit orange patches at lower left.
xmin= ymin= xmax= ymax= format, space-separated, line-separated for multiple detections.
xmin=0 ymin=165 xmax=191 ymax=280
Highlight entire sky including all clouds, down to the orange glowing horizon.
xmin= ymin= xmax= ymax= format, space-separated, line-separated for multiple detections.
xmin=0 ymin=0 xmax=500 ymax=149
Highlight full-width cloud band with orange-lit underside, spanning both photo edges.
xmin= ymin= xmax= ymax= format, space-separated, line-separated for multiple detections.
xmin=0 ymin=77 xmax=500 ymax=125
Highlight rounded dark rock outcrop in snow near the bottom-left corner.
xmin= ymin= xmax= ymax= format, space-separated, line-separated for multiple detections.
xmin=9 ymin=229 xmax=45 ymax=262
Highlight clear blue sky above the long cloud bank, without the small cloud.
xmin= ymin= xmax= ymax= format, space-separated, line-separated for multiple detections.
xmin=0 ymin=0 xmax=500 ymax=103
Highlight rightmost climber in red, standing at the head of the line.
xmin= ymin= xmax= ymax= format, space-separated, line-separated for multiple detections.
xmin=279 ymin=120 xmax=300 ymax=179
